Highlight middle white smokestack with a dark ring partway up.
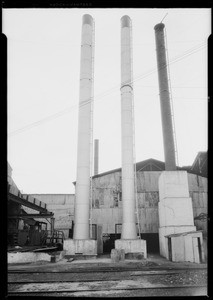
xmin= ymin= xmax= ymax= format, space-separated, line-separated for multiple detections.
xmin=121 ymin=16 xmax=137 ymax=239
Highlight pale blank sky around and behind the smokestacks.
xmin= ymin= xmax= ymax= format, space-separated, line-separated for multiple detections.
xmin=3 ymin=8 xmax=211 ymax=194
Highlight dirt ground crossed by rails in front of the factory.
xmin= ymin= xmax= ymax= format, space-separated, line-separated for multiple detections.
xmin=8 ymin=255 xmax=208 ymax=297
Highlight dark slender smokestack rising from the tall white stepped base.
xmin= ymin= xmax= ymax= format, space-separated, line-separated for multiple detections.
xmin=154 ymin=23 xmax=176 ymax=171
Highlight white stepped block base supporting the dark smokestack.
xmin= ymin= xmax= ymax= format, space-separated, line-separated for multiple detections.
xmin=158 ymin=171 xmax=195 ymax=259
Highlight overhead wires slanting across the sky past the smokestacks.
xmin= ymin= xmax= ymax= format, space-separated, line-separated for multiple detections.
xmin=8 ymin=42 xmax=206 ymax=137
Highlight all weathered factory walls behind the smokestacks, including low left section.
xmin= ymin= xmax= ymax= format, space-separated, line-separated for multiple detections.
xmin=32 ymin=171 xmax=207 ymax=238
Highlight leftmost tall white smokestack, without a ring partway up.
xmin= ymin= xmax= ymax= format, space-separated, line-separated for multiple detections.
xmin=73 ymin=15 xmax=94 ymax=240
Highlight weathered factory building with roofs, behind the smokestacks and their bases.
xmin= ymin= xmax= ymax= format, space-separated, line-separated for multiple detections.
xmin=28 ymin=152 xmax=208 ymax=253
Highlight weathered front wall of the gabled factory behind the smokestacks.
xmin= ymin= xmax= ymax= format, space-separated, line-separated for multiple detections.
xmin=92 ymin=171 xmax=207 ymax=233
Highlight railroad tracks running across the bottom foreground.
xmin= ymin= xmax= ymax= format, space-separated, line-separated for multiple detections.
xmin=8 ymin=268 xmax=207 ymax=297
